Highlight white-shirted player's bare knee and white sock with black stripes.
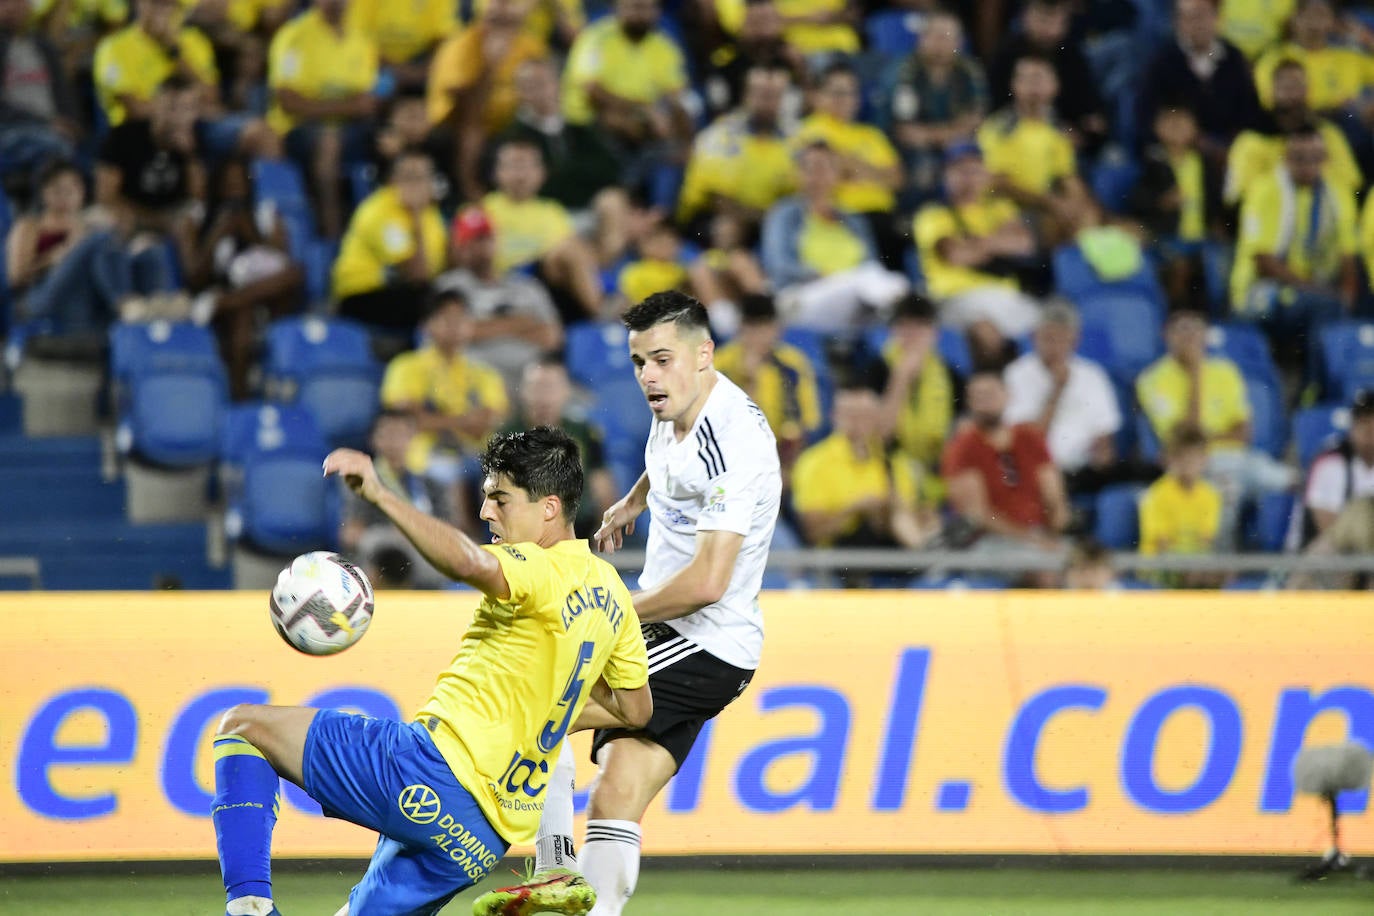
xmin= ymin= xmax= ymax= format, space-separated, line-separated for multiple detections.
xmin=581 ymin=736 xmax=677 ymax=916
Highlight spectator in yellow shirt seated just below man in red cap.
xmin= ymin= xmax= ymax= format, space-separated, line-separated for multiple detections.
xmin=381 ymin=290 xmax=510 ymax=530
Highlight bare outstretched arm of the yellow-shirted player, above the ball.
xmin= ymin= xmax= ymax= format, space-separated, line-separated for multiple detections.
xmin=324 ymin=449 xmax=511 ymax=600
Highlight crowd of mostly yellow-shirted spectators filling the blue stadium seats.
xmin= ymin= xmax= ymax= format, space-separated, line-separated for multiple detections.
xmin=8 ymin=0 xmax=1374 ymax=588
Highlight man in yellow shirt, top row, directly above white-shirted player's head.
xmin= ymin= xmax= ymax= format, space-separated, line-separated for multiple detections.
xmin=563 ymin=0 xmax=694 ymax=209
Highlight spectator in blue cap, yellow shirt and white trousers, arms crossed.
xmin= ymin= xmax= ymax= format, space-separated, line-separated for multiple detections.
xmin=912 ymin=143 xmax=1040 ymax=364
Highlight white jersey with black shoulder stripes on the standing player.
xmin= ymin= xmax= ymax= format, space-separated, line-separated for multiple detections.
xmin=639 ymin=372 xmax=782 ymax=670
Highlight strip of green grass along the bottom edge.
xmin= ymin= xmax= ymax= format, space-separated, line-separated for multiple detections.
xmin=0 ymin=867 xmax=1374 ymax=916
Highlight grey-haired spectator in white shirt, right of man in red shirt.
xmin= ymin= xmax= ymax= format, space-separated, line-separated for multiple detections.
xmin=1003 ymin=299 xmax=1121 ymax=490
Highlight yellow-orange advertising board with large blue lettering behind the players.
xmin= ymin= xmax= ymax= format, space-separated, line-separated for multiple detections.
xmin=0 ymin=592 xmax=1374 ymax=862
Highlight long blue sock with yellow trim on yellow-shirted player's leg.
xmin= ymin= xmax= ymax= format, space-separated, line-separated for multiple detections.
xmin=210 ymin=735 xmax=282 ymax=900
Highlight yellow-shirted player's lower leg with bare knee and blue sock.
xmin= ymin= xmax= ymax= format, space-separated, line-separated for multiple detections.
xmin=210 ymin=706 xmax=317 ymax=916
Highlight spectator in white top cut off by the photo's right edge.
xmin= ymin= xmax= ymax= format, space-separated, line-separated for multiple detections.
xmin=1289 ymin=390 xmax=1374 ymax=548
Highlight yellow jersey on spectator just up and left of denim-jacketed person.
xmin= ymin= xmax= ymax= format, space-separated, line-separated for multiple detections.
xmin=677 ymin=113 xmax=797 ymax=222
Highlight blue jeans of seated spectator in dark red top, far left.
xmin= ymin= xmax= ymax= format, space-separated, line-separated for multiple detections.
xmin=22 ymin=232 xmax=172 ymax=334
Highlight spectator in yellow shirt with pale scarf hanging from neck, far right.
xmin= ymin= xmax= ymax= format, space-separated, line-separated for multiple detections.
xmin=1231 ymin=122 xmax=1359 ymax=364
